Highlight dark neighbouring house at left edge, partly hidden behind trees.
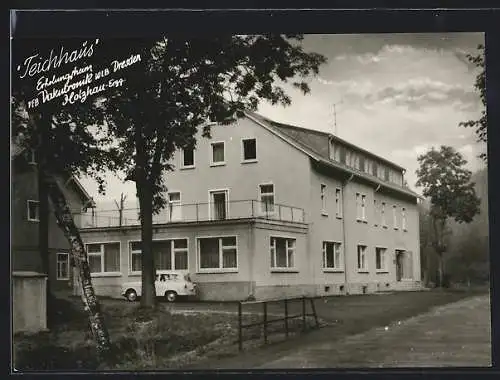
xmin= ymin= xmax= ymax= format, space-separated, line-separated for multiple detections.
xmin=11 ymin=144 xmax=92 ymax=291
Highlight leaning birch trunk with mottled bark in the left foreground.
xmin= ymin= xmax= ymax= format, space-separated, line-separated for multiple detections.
xmin=46 ymin=175 xmax=111 ymax=362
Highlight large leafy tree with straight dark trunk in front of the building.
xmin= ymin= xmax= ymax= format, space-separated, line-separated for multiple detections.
xmin=102 ymin=35 xmax=326 ymax=307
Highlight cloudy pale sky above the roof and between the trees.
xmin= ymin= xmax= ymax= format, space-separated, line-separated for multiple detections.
xmin=81 ymin=33 xmax=486 ymax=207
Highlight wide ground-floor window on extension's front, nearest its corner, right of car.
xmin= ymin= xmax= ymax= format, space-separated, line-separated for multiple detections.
xmin=198 ymin=236 xmax=238 ymax=271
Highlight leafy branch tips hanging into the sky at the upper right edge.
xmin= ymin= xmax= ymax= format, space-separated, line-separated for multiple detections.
xmin=460 ymin=45 xmax=488 ymax=161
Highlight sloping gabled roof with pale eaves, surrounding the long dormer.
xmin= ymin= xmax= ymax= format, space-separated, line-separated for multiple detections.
xmin=245 ymin=111 xmax=419 ymax=197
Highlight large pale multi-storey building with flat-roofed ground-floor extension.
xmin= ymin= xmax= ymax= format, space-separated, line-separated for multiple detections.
xmin=77 ymin=113 xmax=420 ymax=300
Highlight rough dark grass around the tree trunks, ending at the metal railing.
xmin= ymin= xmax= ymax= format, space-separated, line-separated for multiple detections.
xmin=14 ymin=299 xmax=318 ymax=371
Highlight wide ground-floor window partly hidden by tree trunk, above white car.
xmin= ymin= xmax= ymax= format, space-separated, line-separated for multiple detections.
xmin=130 ymin=239 xmax=188 ymax=272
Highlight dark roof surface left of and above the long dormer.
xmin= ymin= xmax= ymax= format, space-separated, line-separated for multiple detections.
xmin=249 ymin=112 xmax=405 ymax=170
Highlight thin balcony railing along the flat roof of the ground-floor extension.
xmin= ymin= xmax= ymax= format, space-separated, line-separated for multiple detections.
xmin=74 ymin=200 xmax=305 ymax=228
